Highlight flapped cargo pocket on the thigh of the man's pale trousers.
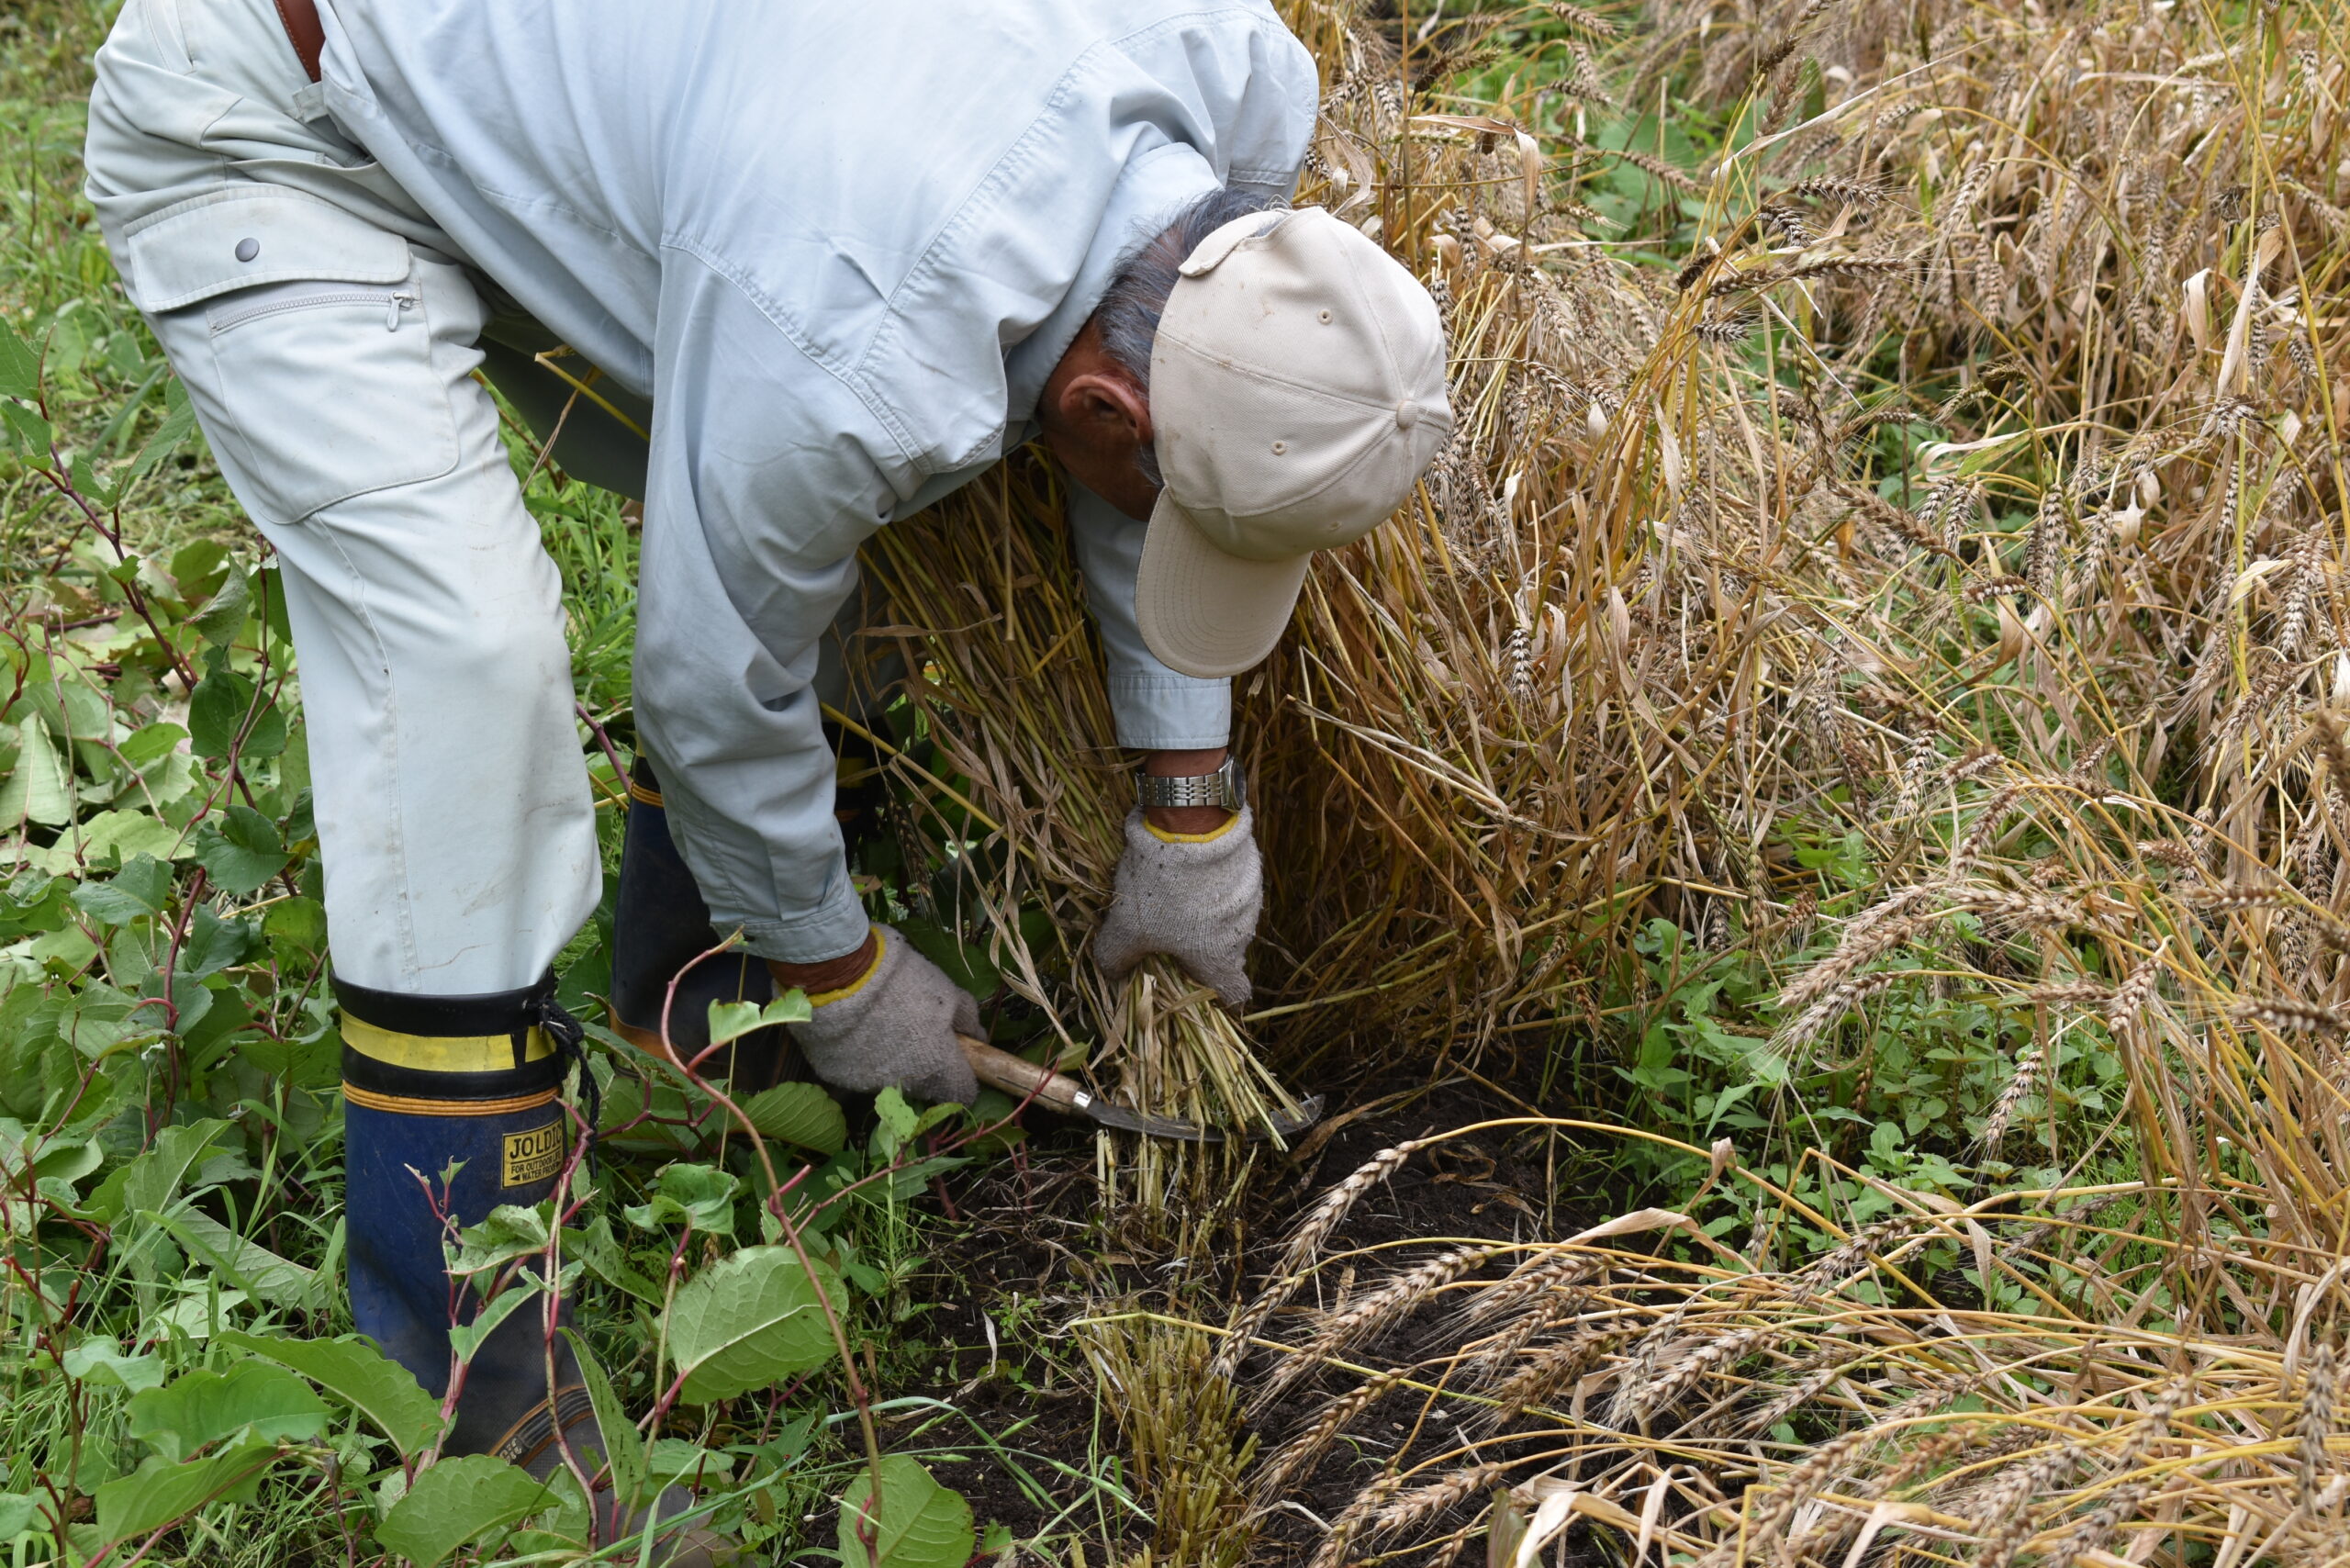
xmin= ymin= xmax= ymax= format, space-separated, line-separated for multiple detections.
xmin=125 ymin=185 xmax=470 ymax=524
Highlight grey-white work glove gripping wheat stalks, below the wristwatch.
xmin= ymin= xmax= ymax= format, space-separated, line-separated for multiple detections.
xmin=1092 ymin=806 xmax=1264 ymax=1009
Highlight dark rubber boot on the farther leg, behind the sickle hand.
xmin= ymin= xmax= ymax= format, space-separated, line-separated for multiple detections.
xmin=611 ymin=755 xmax=811 ymax=1093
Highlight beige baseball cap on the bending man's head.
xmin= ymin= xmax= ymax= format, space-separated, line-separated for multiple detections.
xmin=1135 ymin=207 xmax=1452 ymax=677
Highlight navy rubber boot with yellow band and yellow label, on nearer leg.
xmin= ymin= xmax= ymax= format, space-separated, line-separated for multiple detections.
xmin=334 ymin=976 xmax=729 ymax=1568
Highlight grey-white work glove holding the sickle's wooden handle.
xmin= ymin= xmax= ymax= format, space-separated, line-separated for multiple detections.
xmin=792 ymin=926 xmax=980 ymax=1105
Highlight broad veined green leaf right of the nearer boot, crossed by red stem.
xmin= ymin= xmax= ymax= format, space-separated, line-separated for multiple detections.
xmin=670 ymin=1246 xmax=841 ymax=1404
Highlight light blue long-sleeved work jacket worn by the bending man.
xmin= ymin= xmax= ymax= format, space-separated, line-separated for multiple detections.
xmin=319 ymin=0 xmax=1316 ymax=959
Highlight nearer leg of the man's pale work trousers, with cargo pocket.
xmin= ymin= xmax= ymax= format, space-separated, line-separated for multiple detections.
xmin=89 ymin=0 xmax=599 ymax=997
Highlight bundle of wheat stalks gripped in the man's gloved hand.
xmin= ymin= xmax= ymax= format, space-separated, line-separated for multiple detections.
xmin=863 ymin=458 xmax=1297 ymax=1213
